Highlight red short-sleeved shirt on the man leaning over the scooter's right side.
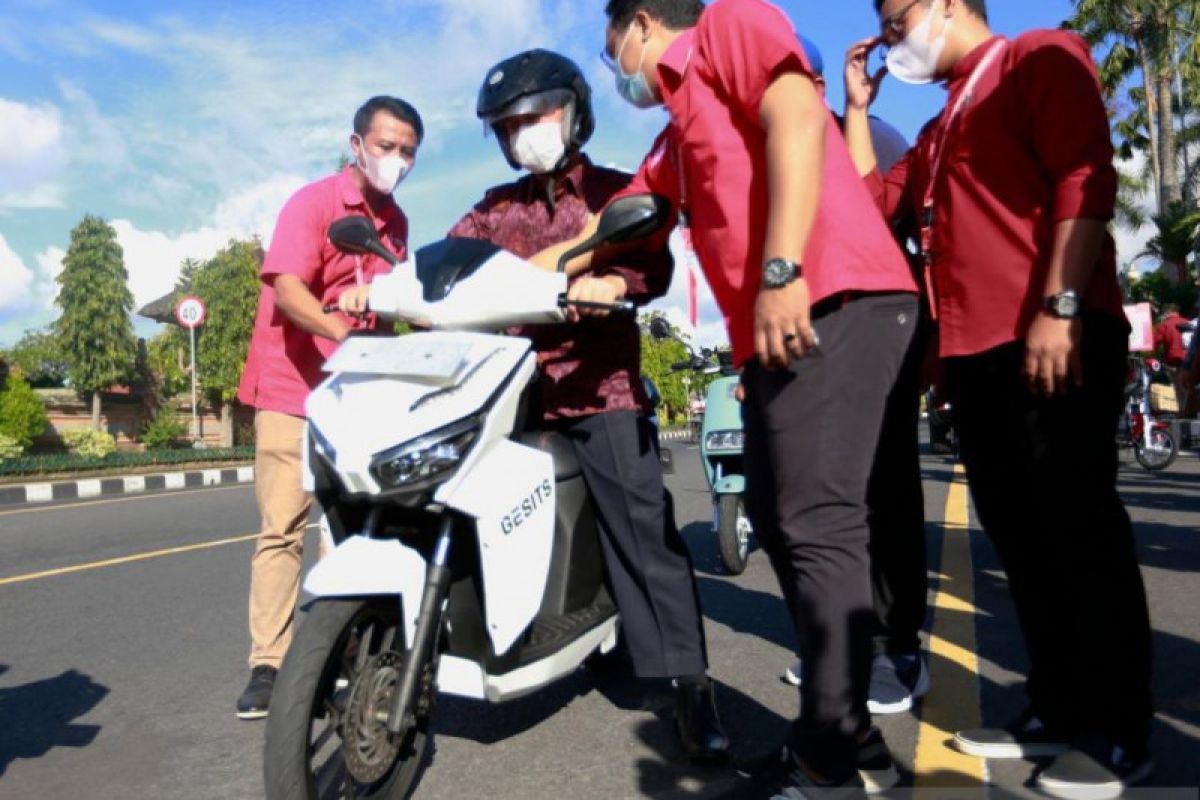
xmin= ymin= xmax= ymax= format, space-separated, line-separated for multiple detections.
xmin=624 ymin=0 xmax=917 ymax=363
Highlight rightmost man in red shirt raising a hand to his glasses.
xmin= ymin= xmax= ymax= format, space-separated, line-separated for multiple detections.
xmin=846 ymin=0 xmax=1152 ymax=798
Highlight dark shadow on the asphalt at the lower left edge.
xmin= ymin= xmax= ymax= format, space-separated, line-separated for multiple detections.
xmin=0 ymin=664 xmax=108 ymax=776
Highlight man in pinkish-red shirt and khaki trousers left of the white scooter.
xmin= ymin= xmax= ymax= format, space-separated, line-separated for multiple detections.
xmin=231 ymin=96 xmax=424 ymax=720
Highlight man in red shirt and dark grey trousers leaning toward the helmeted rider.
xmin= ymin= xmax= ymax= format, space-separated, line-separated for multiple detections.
xmin=535 ymin=0 xmax=917 ymax=790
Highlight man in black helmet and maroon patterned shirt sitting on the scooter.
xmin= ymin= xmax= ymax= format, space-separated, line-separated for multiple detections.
xmin=450 ymin=45 xmax=728 ymax=759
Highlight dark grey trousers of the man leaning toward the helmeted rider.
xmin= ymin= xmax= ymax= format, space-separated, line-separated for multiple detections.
xmin=743 ymin=294 xmax=917 ymax=780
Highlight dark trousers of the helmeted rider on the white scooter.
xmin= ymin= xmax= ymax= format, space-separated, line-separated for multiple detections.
xmin=554 ymin=411 xmax=708 ymax=678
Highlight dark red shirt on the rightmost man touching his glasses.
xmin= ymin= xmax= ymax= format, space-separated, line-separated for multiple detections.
xmin=866 ymin=30 xmax=1124 ymax=356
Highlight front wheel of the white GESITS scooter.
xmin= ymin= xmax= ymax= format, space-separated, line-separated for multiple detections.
xmin=263 ymin=597 xmax=433 ymax=800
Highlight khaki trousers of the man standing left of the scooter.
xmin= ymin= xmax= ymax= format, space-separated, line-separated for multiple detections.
xmin=250 ymin=410 xmax=312 ymax=668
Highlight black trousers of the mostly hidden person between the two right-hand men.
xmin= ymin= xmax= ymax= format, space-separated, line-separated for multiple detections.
xmin=866 ymin=314 xmax=930 ymax=655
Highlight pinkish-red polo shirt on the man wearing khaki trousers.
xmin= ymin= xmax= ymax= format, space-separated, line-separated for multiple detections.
xmin=238 ymin=166 xmax=408 ymax=416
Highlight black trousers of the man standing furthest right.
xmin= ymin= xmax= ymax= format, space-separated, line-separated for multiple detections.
xmin=944 ymin=314 xmax=1153 ymax=748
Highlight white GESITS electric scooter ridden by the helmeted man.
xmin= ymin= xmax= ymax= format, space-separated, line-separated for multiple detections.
xmin=264 ymin=196 xmax=668 ymax=800
